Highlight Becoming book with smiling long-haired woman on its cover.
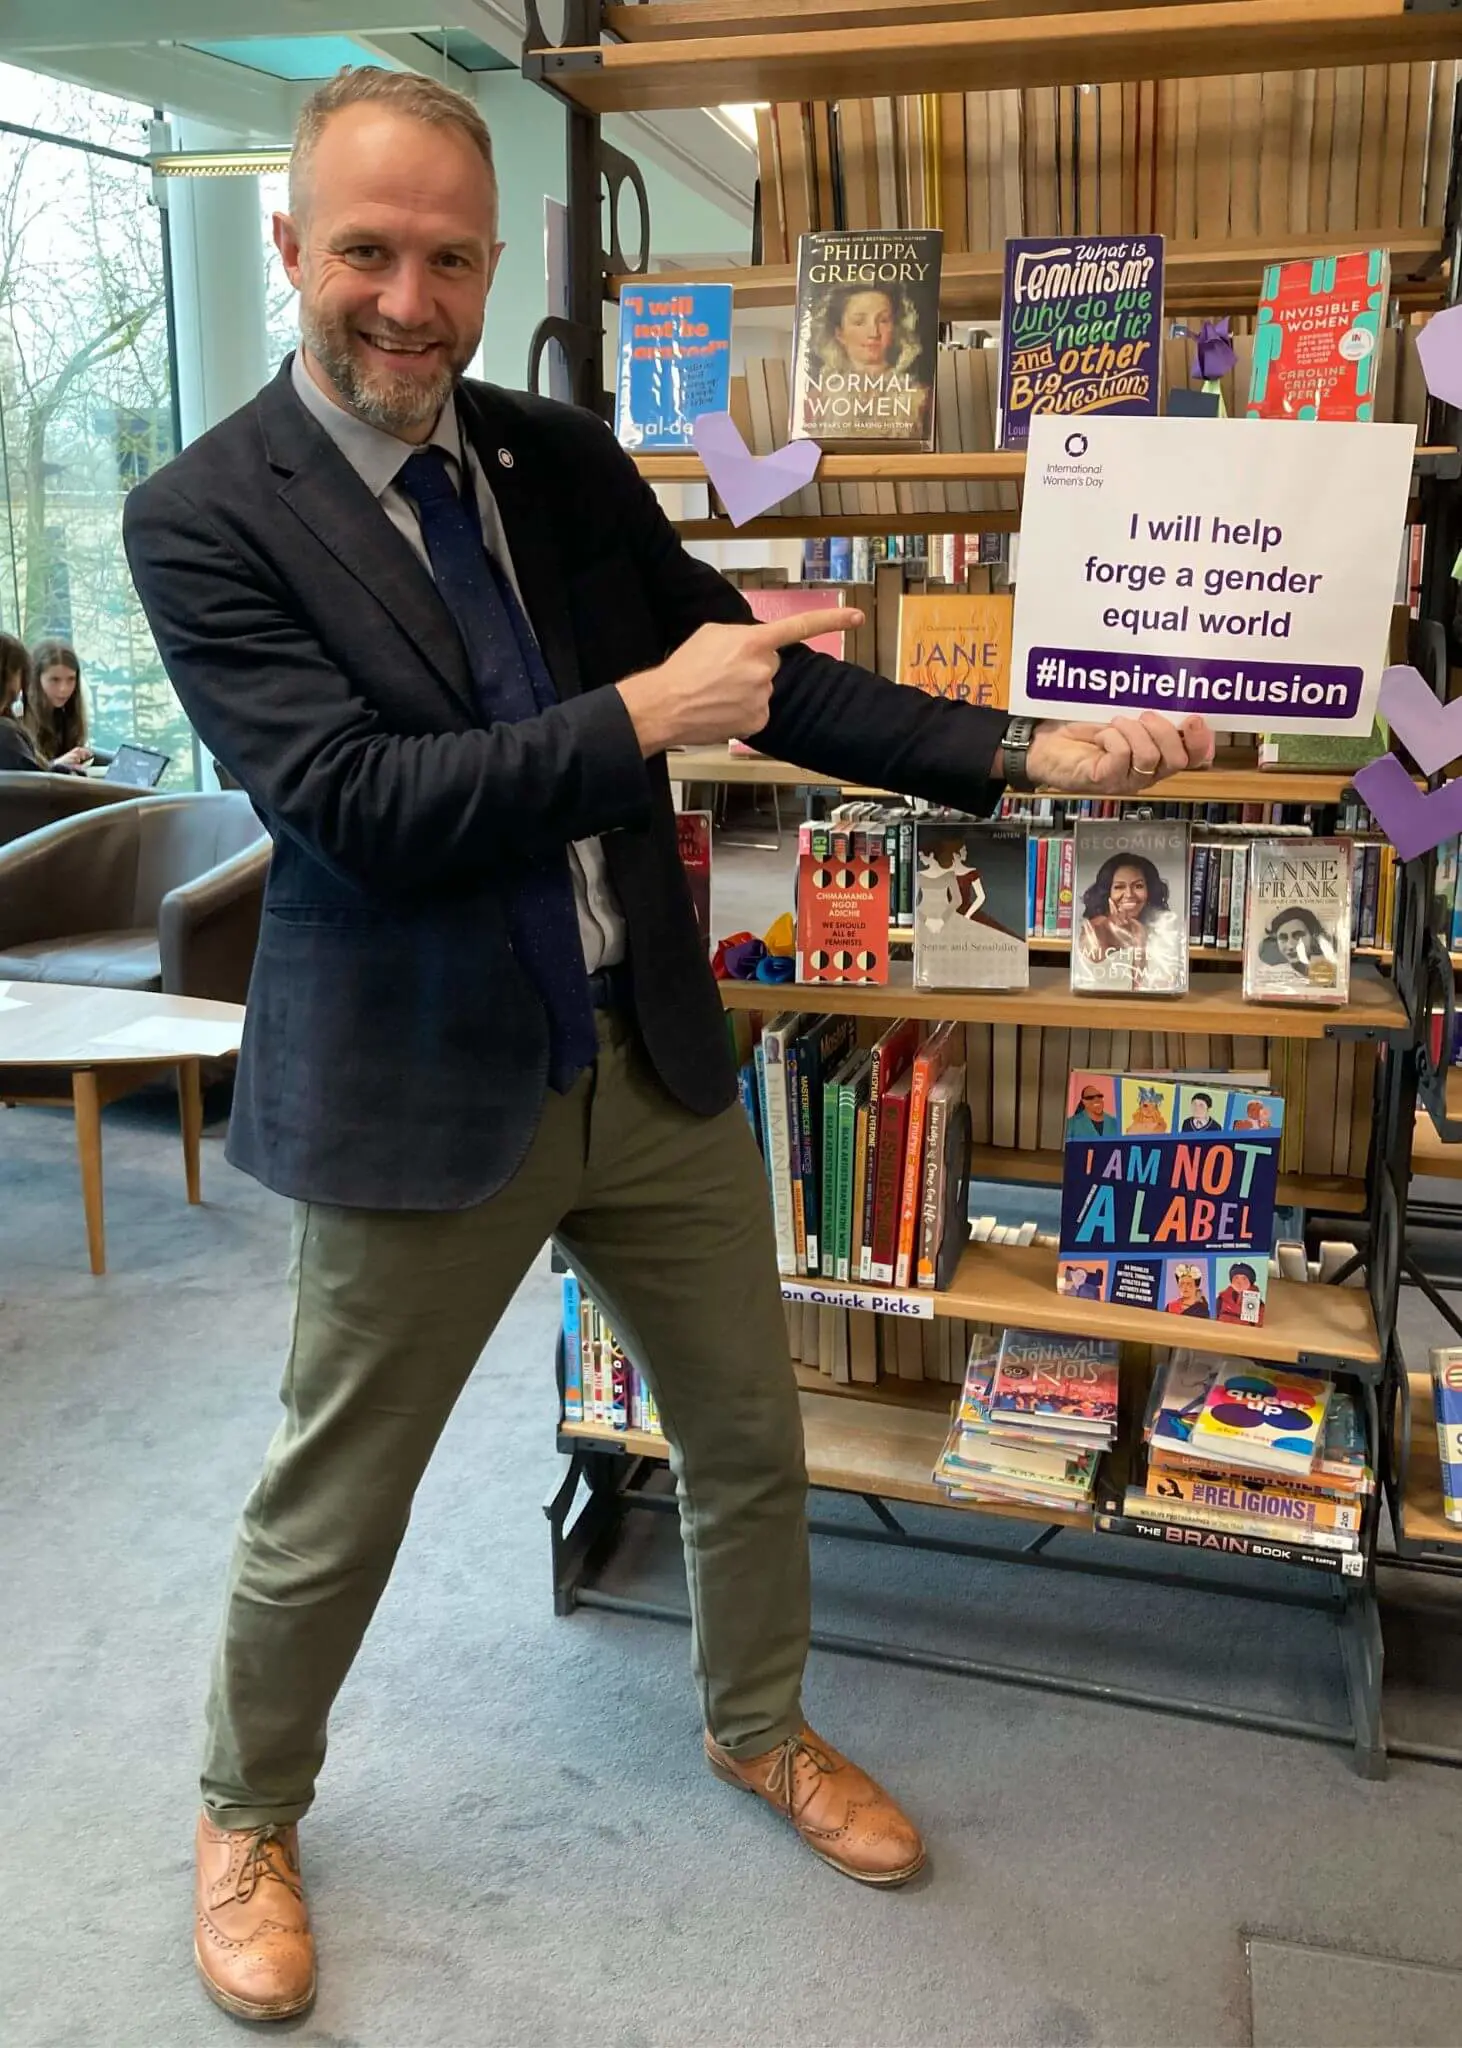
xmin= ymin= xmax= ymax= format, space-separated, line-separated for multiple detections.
xmin=1071 ymin=817 xmax=1188 ymax=995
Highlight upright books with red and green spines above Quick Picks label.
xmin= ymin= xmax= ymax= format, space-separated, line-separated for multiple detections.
xmin=739 ymin=1010 xmax=971 ymax=1288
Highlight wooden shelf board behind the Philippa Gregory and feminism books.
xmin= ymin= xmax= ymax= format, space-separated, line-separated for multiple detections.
xmin=608 ymin=230 xmax=1446 ymax=317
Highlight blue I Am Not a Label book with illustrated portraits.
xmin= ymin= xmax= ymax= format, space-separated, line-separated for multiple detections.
xmin=1057 ymin=1073 xmax=1284 ymax=1325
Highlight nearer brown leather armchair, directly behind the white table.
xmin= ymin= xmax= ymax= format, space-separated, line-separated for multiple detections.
xmin=0 ymin=778 xmax=270 ymax=1004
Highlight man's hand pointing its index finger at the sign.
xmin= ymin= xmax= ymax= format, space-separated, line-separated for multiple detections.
xmin=616 ymin=604 xmax=864 ymax=758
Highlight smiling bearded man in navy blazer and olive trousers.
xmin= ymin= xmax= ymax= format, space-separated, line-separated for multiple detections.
xmin=127 ymin=70 xmax=1212 ymax=2019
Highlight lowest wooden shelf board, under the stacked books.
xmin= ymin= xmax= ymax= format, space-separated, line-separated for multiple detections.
xmin=559 ymin=1374 xmax=1091 ymax=1528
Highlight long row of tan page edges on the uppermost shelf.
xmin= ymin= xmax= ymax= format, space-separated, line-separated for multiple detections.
xmin=756 ymin=61 xmax=1458 ymax=262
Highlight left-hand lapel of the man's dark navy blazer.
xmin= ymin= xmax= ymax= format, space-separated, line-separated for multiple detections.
xmin=258 ymin=362 xmax=475 ymax=725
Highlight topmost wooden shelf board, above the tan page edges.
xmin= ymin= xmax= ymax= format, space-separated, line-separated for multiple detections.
xmin=522 ymin=0 xmax=1462 ymax=115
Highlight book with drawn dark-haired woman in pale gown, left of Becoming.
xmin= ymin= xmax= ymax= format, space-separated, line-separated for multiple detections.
xmin=913 ymin=819 xmax=1030 ymax=989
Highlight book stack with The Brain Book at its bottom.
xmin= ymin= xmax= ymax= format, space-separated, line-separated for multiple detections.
xmin=1098 ymin=1350 xmax=1374 ymax=1573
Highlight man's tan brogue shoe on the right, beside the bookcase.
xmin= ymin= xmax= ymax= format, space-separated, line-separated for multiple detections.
xmin=706 ymin=1724 xmax=923 ymax=1884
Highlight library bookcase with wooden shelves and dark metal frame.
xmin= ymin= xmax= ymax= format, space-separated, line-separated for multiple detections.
xmin=522 ymin=0 xmax=1462 ymax=1776
